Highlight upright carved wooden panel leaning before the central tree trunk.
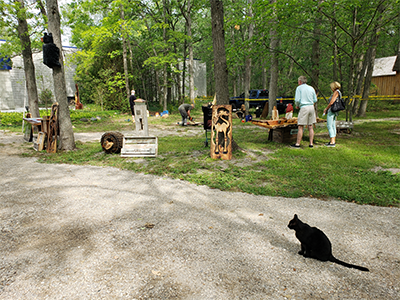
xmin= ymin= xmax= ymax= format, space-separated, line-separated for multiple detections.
xmin=210 ymin=105 xmax=232 ymax=160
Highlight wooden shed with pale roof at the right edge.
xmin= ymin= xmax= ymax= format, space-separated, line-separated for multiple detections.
xmin=372 ymin=51 xmax=400 ymax=96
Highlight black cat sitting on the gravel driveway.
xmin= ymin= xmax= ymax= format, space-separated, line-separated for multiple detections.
xmin=288 ymin=215 xmax=369 ymax=272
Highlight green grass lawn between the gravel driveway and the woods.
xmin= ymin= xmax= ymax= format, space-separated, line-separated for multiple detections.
xmin=3 ymin=105 xmax=400 ymax=207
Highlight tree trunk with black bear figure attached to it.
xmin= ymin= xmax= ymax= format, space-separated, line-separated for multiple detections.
xmin=46 ymin=0 xmax=75 ymax=150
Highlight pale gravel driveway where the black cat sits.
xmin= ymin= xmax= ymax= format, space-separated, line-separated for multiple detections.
xmin=0 ymin=134 xmax=400 ymax=300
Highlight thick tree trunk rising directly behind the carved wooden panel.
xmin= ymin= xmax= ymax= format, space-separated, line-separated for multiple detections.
xmin=210 ymin=0 xmax=229 ymax=105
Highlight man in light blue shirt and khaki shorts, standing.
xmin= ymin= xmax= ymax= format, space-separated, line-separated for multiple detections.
xmin=291 ymin=76 xmax=317 ymax=149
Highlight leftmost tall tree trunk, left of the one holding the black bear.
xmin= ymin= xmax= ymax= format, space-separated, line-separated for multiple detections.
xmin=16 ymin=0 xmax=40 ymax=118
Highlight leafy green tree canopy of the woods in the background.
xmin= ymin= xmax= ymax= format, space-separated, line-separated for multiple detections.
xmin=3 ymin=0 xmax=400 ymax=109
